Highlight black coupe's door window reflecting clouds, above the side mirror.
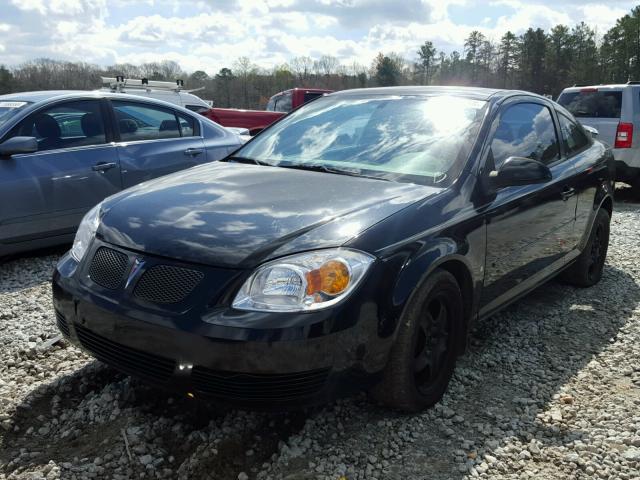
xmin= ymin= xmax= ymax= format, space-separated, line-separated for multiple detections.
xmin=491 ymin=103 xmax=560 ymax=168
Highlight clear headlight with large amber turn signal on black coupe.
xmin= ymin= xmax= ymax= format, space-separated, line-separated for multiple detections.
xmin=233 ymin=248 xmax=374 ymax=312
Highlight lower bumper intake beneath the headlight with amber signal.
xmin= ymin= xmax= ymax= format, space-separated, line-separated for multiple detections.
xmin=191 ymin=366 xmax=329 ymax=402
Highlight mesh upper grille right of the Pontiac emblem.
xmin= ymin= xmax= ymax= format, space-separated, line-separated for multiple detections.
xmin=133 ymin=265 xmax=204 ymax=303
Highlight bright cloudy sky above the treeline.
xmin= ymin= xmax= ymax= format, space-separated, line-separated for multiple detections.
xmin=0 ymin=0 xmax=638 ymax=74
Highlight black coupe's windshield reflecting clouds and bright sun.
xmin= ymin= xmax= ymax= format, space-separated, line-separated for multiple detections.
xmin=236 ymin=95 xmax=487 ymax=187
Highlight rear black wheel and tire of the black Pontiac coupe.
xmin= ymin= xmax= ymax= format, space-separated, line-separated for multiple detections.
xmin=561 ymin=208 xmax=611 ymax=287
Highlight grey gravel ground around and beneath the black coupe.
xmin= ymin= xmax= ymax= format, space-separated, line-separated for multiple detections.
xmin=0 ymin=189 xmax=640 ymax=480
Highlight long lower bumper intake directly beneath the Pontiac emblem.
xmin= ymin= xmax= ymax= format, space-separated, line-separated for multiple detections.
xmin=75 ymin=325 xmax=175 ymax=382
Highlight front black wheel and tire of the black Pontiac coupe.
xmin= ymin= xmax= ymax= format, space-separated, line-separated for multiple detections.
xmin=371 ymin=269 xmax=464 ymax=412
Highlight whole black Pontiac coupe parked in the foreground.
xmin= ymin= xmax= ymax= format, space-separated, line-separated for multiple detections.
xmin=53 ymin=87 xmax=613 ymax=411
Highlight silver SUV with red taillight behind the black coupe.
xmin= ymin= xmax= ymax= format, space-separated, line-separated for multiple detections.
xmin=558 ymin=82 xmax=640 ymax=191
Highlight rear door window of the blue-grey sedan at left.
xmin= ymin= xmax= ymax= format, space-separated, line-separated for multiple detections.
xmin=112 ymin=101 xmax=180 ymax=142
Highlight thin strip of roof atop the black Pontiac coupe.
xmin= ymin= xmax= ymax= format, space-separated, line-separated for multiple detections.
xmin=329 ymin=86 xmax=544 ymax=100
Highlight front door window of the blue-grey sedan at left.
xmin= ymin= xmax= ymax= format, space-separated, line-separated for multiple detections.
xmin=10 ymin=100 xmax=106 ymax=151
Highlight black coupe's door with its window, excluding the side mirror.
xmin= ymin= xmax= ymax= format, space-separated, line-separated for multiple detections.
xmin=480 ymin=98 xmax=577 ymax=316
